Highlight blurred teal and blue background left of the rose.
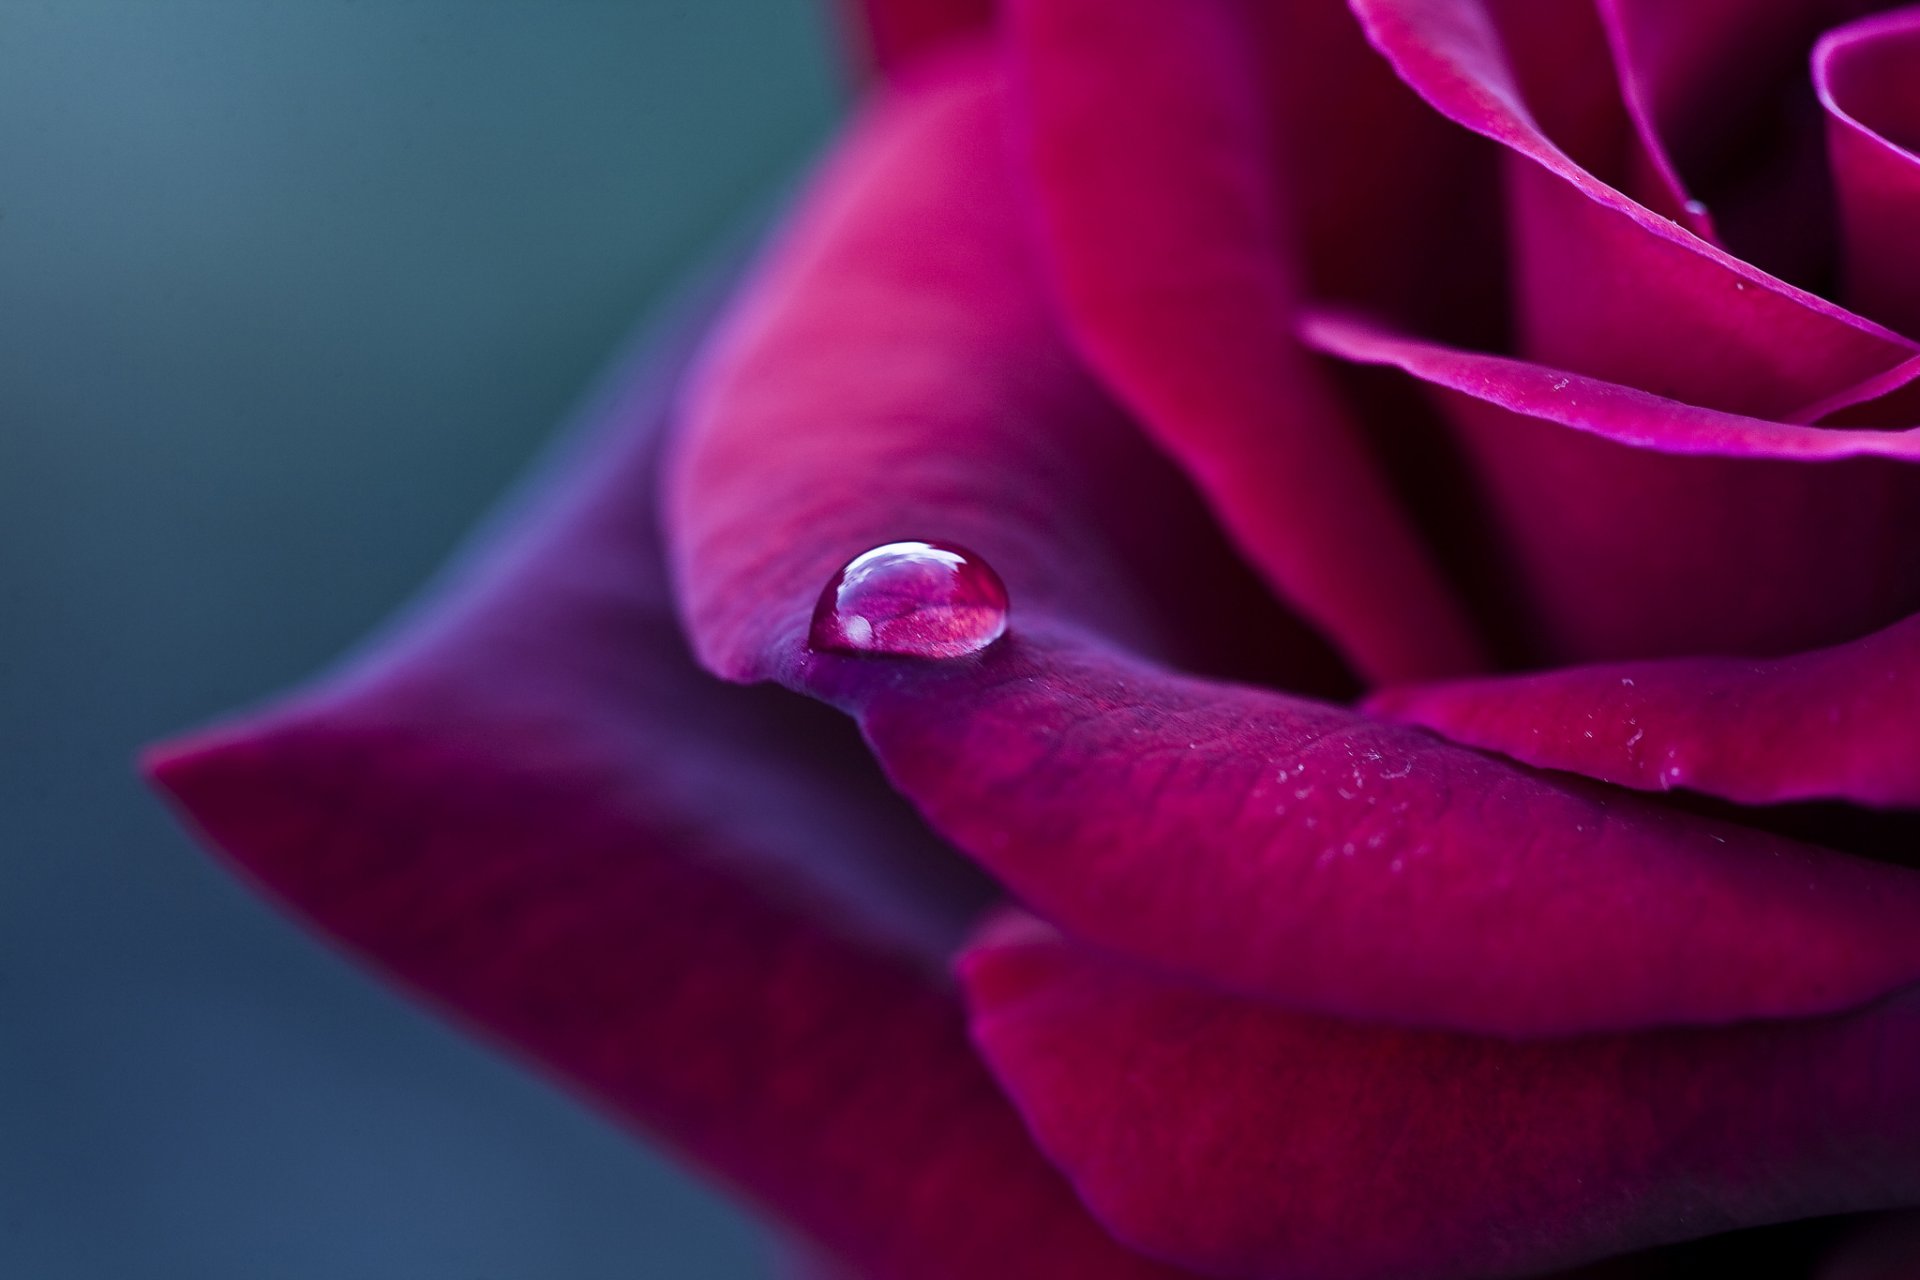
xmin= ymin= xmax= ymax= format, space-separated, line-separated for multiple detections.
xmin=0 ymin=0 xmax=841 ymax=1280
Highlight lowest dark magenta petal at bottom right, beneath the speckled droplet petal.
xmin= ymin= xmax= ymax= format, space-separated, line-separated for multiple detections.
xmin=962 ymin=923 xmax=1920 ymax=1280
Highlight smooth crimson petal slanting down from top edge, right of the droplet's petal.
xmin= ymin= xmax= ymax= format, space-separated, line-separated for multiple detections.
xmin=1008 ymin=0 xmax=1480 ymax=677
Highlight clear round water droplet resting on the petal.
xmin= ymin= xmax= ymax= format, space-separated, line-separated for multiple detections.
xmin=806 ymin=541 xmax=1006 ymax=658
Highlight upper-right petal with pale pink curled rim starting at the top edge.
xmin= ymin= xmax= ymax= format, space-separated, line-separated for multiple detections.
xmin=1352 ymin=0 xmax=1914 ymax=415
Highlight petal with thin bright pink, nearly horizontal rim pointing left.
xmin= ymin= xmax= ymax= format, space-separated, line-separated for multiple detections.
xmin=1302 ymin=315 xmax=1920 ymax=662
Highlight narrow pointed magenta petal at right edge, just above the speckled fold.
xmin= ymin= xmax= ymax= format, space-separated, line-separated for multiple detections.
xmin=1369 ymin=618 xmax=1920 ymax=808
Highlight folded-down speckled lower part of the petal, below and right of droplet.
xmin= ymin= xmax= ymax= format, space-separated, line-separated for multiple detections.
xmin=837 ymin=629 xmax=1920 ymax=1036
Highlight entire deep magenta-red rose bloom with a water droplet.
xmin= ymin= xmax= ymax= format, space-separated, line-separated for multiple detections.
xmin=154 ymin=0 xmax=1920 ymax=1280
